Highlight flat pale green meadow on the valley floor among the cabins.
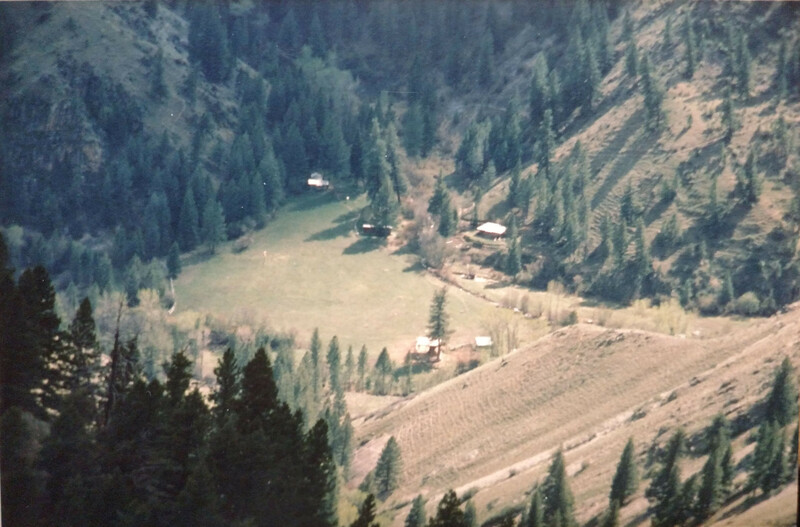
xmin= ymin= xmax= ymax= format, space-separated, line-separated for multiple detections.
xmin=175 ymin=193 xmax=541 ymax=360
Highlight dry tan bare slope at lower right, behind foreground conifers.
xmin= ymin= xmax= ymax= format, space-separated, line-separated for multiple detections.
xmin=353 ymin=304 xmax=800 ymax=525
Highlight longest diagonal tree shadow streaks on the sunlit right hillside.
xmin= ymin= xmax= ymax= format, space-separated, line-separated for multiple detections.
xmin=591 ymin=108 xmax=657 ymax=210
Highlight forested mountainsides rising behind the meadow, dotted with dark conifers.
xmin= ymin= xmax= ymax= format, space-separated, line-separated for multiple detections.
xmin=0 ymin=2 xmax=800 ymax=314
